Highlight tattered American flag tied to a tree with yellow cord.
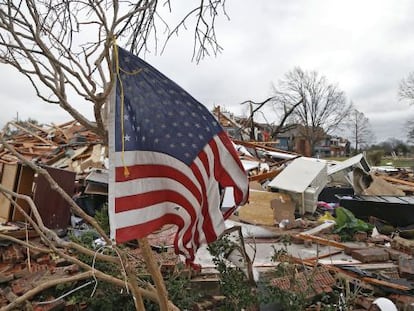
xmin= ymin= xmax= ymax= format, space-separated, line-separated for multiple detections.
xmin=109 ymin=48 xmax=248 ymax=262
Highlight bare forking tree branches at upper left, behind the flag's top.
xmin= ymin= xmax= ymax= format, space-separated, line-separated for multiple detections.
xmin=0 ymin=0 xmax=226 ymax=138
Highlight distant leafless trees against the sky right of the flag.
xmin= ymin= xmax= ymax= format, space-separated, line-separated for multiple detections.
xmin=242 ymin=67 xmax=414 ymax=154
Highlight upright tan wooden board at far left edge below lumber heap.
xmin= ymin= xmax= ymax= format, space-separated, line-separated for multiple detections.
xmin=0 ymin=164 xmax=19 ymax=222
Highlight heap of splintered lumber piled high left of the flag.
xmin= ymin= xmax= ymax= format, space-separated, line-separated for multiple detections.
xmin=0 ymin=121 xmax=107 ymax=174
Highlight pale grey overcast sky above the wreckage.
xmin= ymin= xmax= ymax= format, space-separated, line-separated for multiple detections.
xmin=0 ymin=0 xmax=414 ymax=141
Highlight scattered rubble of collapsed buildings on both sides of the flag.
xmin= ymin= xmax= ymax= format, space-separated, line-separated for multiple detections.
xmin=0 ymin=121 xmax=414 ymax=310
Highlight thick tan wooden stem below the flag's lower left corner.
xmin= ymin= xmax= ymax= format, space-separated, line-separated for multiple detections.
xmin=138 ymin=238 xmax=168 ymax=311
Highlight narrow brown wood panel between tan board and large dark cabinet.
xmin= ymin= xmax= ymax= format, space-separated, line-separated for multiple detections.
xmin=12 ymin=166 xmax=34 ymax=221
